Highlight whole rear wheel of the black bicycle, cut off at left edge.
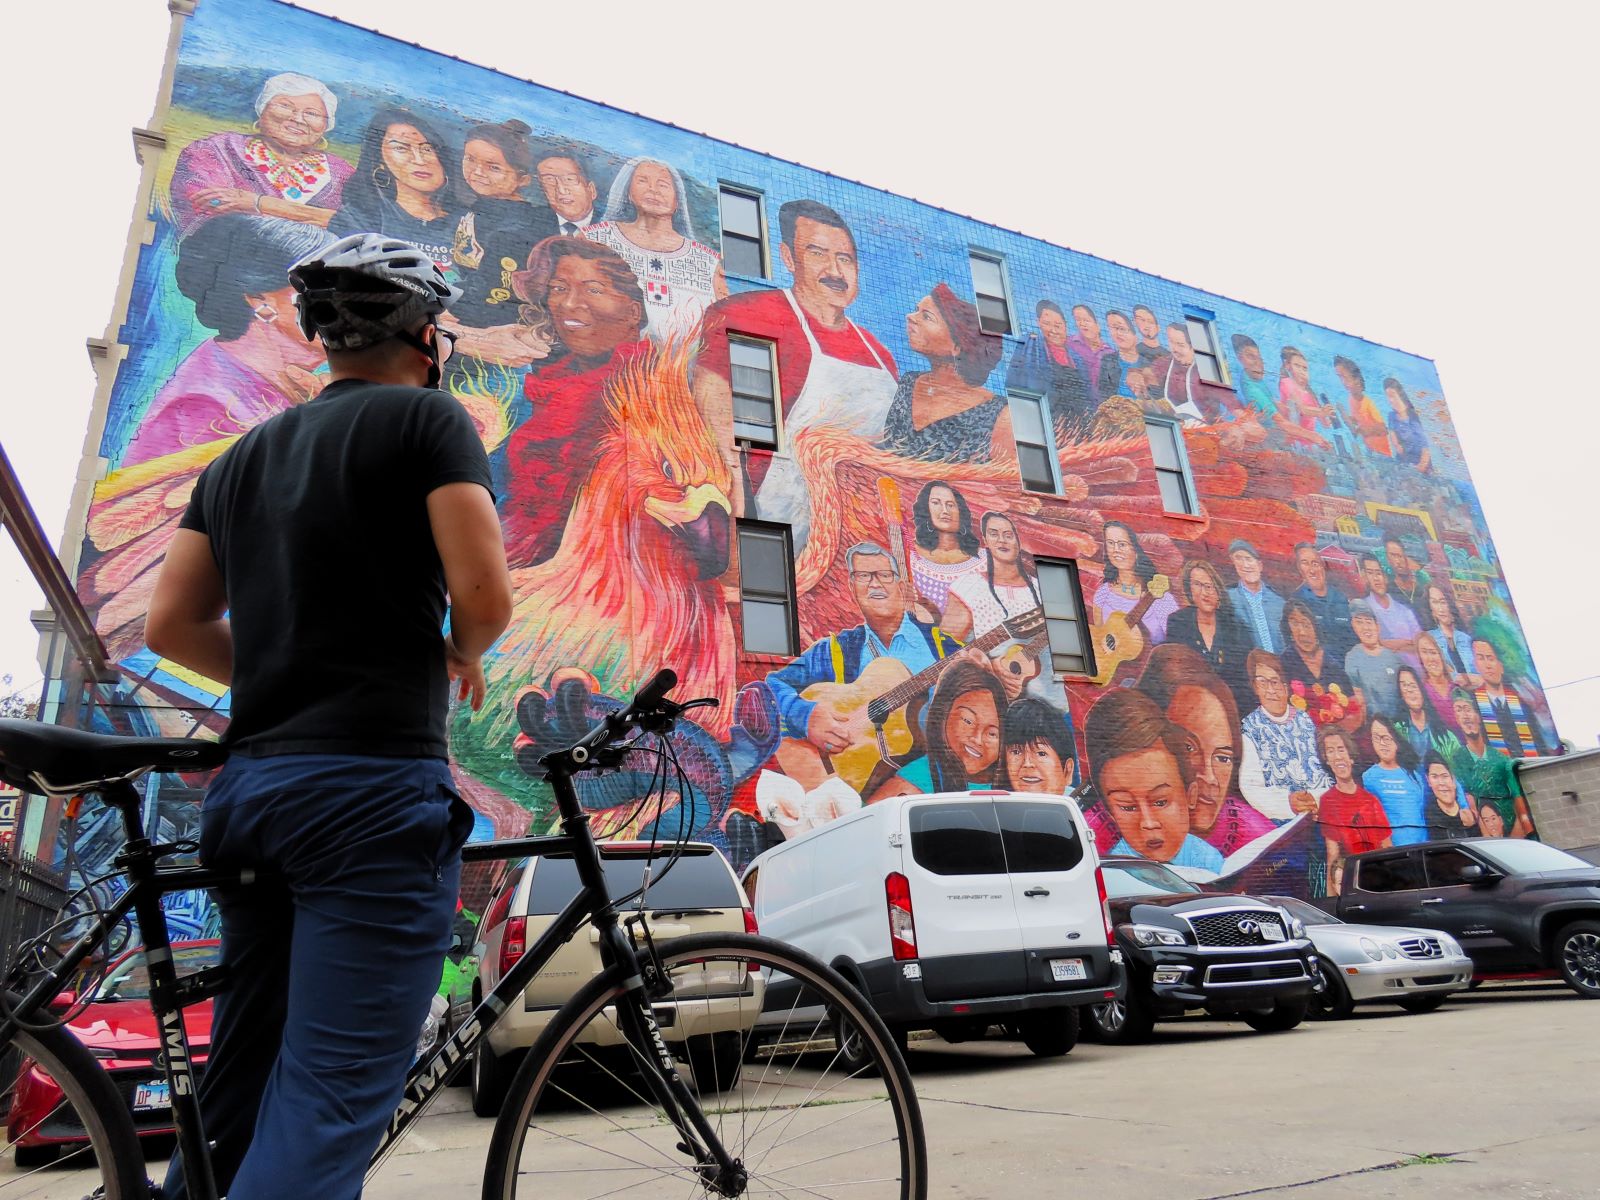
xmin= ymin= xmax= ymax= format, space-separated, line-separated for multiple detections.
xmin=0 ymin=995 xmax=150 ymax=1200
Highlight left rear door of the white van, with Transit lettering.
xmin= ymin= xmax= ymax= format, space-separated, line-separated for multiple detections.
xmin=901 ymin=797 xmax=1027 ymax=1000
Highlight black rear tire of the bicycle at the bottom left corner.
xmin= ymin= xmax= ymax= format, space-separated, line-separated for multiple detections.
xmin=0 ymin=992 xmax=150 ymax=1200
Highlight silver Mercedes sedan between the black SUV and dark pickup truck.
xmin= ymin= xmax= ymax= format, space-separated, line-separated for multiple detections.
xmin=1266 ymin=896 xmax=1472 ymax=1019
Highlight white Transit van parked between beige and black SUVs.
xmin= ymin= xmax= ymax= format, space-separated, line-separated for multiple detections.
xmin=744 ymin=790 xmax=1123 ymax=1058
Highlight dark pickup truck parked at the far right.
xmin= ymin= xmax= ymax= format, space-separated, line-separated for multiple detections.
xmin=1330 ymin=837 xmax=1600 ymax=1000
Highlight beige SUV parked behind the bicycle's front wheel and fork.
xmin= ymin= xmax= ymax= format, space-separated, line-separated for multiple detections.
xmin=470 ymin=842 xmax=763 ymax=1117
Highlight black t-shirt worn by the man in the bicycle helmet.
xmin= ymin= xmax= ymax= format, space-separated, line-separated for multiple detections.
xmin=181 ymin=379 xmax=493 ymax=758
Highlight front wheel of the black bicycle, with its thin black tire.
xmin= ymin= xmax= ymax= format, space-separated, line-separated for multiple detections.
xmin=483 ymin=933 xmax=928 ymax=1200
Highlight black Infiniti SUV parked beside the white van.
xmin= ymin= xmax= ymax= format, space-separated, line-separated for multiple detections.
xmin=1090 ymin=858 xmax=1322 ymax=1042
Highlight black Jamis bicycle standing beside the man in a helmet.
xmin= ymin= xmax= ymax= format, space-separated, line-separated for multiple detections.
xmin=0 ymin=670 xmax=928 ymax=1200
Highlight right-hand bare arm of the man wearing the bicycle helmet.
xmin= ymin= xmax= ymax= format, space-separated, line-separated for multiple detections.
xmin=427 ymin=482 xmax=510 ymax=710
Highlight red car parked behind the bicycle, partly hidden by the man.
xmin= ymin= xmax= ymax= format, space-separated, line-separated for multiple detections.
xmin=6 ymin=939 xmax=221 ymax=1168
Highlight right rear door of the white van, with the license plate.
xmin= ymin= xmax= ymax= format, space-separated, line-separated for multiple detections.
xmin=992 ymin=794 xmax=1106 ymax=990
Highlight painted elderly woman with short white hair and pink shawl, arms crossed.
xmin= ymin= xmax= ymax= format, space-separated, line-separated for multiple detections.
xmin=171 ymin=74 xmax=355 ymax=237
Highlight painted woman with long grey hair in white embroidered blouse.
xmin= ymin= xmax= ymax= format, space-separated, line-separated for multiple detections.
xmin=584 ymin=158 xmax=728 ymax=344
